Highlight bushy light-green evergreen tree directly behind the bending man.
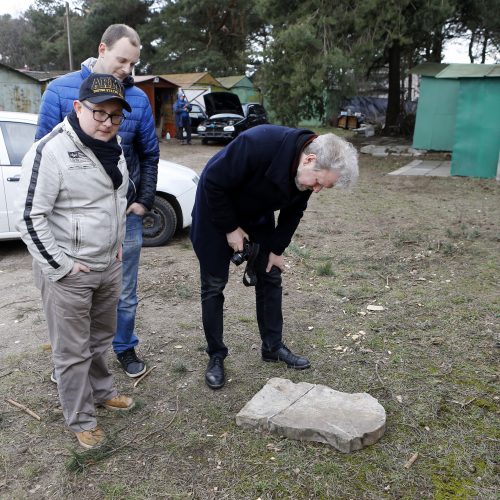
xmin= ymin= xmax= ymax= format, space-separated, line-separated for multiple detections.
xmin=257 ymin=0 xmax=358 ymax=125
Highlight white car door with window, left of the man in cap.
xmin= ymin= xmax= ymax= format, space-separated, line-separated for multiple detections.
xmin=0 ymin=121 xmax=36 ymax=232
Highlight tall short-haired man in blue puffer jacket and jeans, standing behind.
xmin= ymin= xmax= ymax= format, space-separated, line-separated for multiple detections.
xmin=36 ymin=24 xmax=160 ymax=381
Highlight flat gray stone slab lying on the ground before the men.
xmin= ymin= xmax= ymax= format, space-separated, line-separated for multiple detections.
xmin=236 ymin=378 xmax=386 ymax=453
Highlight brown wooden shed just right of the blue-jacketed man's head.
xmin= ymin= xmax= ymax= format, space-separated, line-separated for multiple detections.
xmin=134 ymin=75 xmax=179 ymax=139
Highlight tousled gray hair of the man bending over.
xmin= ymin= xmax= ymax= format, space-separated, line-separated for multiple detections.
xmin=303 ymin=134 xmax=359 ymax=189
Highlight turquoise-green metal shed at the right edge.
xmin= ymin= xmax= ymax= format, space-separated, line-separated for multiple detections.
xmin=412 ymin=63 xmax=500 ymax=178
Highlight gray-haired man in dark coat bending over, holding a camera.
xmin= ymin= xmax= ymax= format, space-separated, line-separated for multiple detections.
xmin=191 ymin=125 xmax=358 ymax=389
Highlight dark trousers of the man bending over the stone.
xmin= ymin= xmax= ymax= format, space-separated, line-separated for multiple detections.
xmin=200 ymin=251 xmax=283 ymax=358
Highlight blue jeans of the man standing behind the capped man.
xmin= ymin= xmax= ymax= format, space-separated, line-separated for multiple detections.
xmin=113 ymin=213 xmax=142 ymax=354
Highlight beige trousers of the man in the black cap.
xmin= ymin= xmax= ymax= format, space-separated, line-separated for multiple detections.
xmin=33 ymin=260 xmax=122 ymax=432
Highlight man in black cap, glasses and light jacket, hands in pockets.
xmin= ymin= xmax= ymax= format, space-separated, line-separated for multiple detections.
xmin=16 ymin=73 xmax=134 ymax=448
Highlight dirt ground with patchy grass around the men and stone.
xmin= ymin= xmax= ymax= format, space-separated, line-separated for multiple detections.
xmin=0 ymin=134 xmax=500 ymax=500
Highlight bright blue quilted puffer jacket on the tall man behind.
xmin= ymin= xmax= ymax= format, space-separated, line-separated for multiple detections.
xmin=35 ymin=58 xmax=160 ymax=210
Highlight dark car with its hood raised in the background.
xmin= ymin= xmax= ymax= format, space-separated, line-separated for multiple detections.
xmin=197 ymin=92 xmax=269 ymax=144
